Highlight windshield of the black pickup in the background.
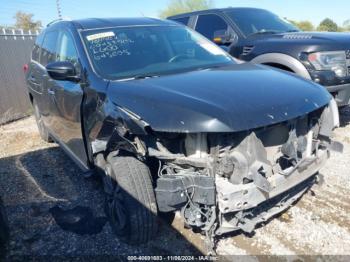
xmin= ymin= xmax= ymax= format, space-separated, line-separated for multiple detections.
xmin=227 ymin=9 xmax=299 ymax=36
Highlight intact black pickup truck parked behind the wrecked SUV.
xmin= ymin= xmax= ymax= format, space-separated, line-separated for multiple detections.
xmin=168 ymin=8 xmax=350 ymax=106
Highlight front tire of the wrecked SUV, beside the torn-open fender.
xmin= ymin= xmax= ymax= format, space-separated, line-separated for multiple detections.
xmin=104 ymin=153 xmax=158 ymax=244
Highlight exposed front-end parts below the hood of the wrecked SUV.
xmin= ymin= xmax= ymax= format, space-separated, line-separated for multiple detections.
xmin=147 ymin=103 xmax=341 ymax=239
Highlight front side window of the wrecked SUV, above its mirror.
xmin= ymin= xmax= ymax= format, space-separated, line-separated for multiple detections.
xmin=56 ymin=31 xmax=79 ymax=67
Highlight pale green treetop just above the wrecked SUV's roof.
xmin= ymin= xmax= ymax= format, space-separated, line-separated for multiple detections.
xmin=159 ymin=0 xmax=213 ymax=18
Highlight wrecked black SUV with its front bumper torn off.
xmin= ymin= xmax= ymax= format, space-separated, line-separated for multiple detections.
xmin=26 ymin=18 xmax=339 ymax=246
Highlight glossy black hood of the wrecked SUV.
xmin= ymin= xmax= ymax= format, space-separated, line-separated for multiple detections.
xmin=108 ymin=63 xmax=330 ymax=132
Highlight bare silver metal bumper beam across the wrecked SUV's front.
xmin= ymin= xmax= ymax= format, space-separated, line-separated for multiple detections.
xmin=216 ymin=149 xmax=329 ymax=235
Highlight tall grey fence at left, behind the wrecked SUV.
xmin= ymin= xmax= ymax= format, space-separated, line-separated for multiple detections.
xmin=0 ymin=28 xmax=39 ymax=124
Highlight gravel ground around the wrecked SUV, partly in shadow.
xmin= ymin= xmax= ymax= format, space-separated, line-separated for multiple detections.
xmin=0 ymin=108 xmax=350 ymax=260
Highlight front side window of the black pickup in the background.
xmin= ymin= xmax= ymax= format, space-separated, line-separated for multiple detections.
xmin=196 ymin=14 xmax=228 ymax=40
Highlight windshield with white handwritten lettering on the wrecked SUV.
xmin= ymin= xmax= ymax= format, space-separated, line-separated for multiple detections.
xmin=82 ymin=26 xmax=235 ymax=79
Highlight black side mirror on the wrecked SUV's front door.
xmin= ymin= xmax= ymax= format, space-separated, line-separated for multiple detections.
xmin=46 ymin=61 xmax=80 ymax=82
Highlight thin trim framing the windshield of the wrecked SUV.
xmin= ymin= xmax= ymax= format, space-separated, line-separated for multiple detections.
xmin=78 ymin=23 xmax=237 ymax=81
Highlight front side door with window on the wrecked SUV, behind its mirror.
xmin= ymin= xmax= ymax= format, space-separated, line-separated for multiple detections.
xmin=48 ymin=29 xmax=87 ymax=168
